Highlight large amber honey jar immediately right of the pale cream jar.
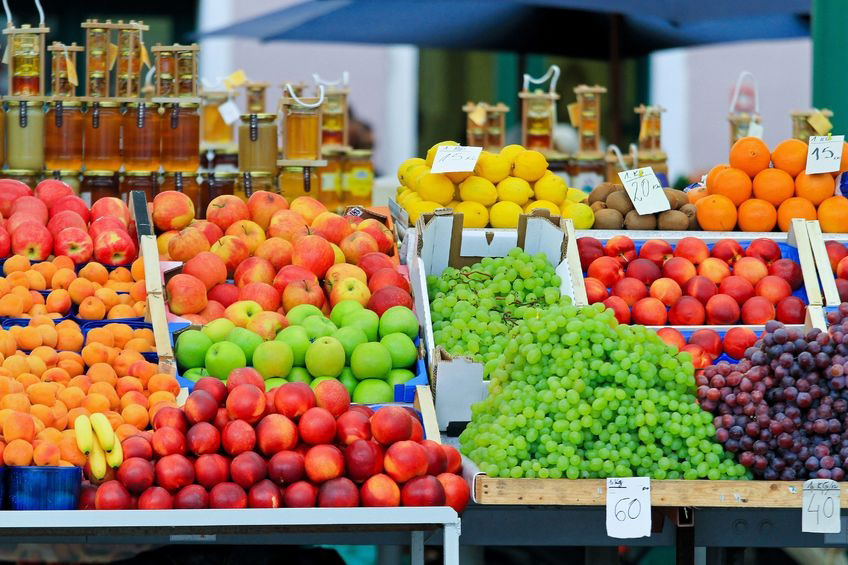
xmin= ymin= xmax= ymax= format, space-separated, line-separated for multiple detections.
xmin=44 ymin=100 xmax=83 ymax=171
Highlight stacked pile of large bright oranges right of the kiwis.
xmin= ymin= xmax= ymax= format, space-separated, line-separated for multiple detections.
xmin=689 ymin=137 xmax=848 ymax=232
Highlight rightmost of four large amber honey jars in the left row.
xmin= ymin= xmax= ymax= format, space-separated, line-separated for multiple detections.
xmin=160 ymin=102 xmax=200 ymax=173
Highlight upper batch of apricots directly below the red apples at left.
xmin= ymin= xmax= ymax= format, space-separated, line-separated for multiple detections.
xmin=0 ymin=255 xmax=147 ymax=320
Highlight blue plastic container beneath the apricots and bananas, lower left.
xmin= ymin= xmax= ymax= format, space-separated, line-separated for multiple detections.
xmin=6 ymin=467 xmax=82 ymax=510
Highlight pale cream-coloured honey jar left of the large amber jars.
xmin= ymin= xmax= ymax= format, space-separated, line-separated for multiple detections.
xmin=6 ymin=100 xmax=44 ymax=171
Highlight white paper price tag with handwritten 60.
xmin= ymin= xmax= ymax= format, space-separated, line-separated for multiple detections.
xmin=607 ymin=477 xmax=651 ymax=539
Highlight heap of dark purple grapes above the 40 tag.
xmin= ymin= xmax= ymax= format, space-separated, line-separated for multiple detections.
xmin=696 ymin=303 xmax=848 ymax=481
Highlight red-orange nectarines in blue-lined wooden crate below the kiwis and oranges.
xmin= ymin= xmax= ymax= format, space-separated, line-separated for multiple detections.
xmin=577 ymin=236 xmax=808 ymax=326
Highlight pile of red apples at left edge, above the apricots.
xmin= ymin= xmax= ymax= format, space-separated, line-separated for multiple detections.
xmin=0 ymin=179 xmax=138 ymax=265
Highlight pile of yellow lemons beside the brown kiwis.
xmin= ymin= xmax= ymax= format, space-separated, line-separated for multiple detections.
xmin=396 ymin=141 xmax=595 ymax=229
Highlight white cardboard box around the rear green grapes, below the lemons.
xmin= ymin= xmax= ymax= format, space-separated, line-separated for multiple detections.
xmin=409 ymin=210 xmax=580 ymax=430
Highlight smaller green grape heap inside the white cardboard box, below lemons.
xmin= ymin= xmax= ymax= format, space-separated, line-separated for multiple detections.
xmin=427 ymin=248 xmax=561 ymax=375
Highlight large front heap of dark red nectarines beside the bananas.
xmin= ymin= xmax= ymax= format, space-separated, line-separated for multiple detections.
xmin=85 ymin=369 xmax=469 ymax=512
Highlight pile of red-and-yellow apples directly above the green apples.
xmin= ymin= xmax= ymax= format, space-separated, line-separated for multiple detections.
xmin=153 ymin=191 xmax=412 ymax=330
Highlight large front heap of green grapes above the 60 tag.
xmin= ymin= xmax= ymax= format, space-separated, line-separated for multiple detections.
xmin=460 ymin=297 xmax=749 ymax=479
